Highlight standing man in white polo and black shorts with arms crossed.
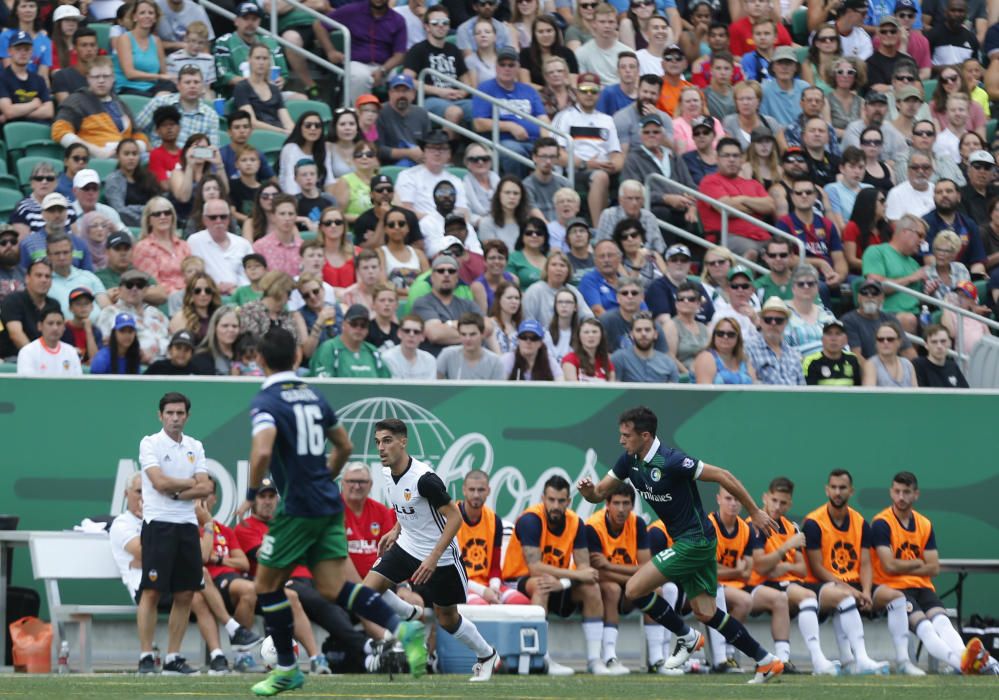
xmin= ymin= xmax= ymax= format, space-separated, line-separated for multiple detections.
xmin=136 ymin=392 xmax=214 ymax=675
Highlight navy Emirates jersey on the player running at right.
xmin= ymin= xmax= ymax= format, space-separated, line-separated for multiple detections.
xmin=611 ymin=438 xmax=716 ymax=540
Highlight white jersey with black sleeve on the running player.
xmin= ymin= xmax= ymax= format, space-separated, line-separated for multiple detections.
xmin=382 ymin=457 xmax=461 ymax=566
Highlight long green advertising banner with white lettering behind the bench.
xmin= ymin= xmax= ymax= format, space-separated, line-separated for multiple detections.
xmin=0 ymin=377 xmax=999 ymax=614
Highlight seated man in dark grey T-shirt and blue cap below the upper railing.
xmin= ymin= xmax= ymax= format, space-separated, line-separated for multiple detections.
xmin=377 ymin=74 xmax=434 ymax=167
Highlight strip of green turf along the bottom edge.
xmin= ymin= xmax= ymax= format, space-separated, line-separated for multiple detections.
xmin=0 ymin=674 xmax=999 ymax=700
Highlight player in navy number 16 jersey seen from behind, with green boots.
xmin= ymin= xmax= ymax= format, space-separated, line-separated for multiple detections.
xmin=238 ymin=328 xmax=427 ymax=695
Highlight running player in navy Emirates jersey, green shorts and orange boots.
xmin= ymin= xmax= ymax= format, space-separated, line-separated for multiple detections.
xmin=577 ymin=406 xmax=784 ymax=684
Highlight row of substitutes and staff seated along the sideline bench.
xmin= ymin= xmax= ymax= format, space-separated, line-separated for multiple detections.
xmin=110 ymin=456 xmax=997 ymax=676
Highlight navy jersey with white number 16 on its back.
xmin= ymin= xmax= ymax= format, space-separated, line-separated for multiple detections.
xmin=250 ymin=372 xmax=343 ymax=517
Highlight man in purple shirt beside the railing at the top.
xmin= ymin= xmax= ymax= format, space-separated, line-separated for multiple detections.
xmin=324 ymin=0 xmax=410 ymax=102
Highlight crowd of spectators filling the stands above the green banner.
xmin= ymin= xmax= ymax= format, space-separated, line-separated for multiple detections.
xmin=0 ymin=0 xmax=999 ymax=387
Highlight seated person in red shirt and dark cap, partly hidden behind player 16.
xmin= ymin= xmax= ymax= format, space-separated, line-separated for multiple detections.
xmin=235 ymin=478 xmax=372 ymax=674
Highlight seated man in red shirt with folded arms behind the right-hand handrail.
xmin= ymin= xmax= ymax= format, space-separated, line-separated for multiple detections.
xmin=697 ymin=137 xmax=776 ymax=260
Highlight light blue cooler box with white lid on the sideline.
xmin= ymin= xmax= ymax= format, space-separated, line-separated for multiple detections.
xmin=437 ymin=605 xmax=548 ymax=674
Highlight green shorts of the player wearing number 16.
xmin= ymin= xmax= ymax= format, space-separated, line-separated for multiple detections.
xmin=257 ymin=512 xmax=347 ymax=569
